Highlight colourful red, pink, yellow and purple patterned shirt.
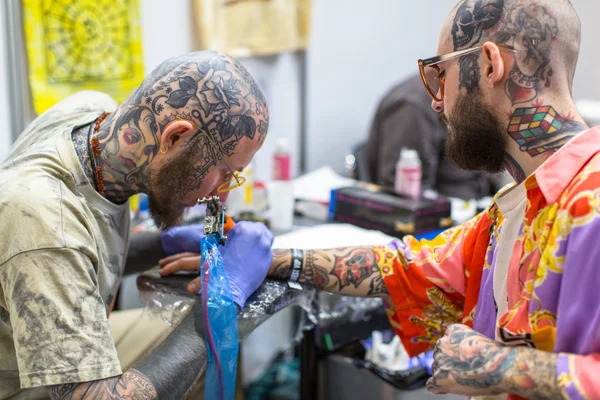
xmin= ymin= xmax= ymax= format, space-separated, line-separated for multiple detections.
xmin=376 ymin=127 xmax=600 ymax=399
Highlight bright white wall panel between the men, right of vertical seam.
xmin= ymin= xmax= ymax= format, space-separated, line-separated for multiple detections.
xmin=307 ymin=0 xmax=452 ymax=172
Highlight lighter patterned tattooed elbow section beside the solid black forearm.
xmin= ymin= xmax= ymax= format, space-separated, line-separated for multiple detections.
xmin=48 ymin=369 xmax=158 ymax=400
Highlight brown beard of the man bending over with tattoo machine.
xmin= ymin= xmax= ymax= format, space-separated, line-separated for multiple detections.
xmin=148 ymin=150 xmax=194 ymax=230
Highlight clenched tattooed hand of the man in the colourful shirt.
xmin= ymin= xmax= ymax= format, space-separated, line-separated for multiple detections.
xmin=427 ymin=325 xmax=514 ymax=396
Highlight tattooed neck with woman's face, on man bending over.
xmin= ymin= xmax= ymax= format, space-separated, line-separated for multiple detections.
xmin=71 ymin=110 xmax=156 ymax=204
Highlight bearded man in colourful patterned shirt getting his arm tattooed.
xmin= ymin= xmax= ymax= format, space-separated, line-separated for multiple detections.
xmin=164 ymin=0 xmax=600 ymax=399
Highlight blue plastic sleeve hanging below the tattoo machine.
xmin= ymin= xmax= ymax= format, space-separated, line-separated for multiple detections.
xmin=200 ymin=234 xmax=238 ymax=400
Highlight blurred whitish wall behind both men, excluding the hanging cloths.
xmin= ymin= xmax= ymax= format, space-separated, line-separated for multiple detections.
xmin=0 ymin=0 xmax=600 ymax=173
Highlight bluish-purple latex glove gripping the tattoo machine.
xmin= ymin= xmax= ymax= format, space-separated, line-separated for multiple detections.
xmin=219 ymin=221 xmax=273 ymax=308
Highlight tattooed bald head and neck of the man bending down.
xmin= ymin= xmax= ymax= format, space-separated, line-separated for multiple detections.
xmin=73 ymin=51 xmax=269 ymax=228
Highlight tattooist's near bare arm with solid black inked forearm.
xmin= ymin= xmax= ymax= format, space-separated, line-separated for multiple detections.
xmin=48 ymin=303 xmax=207 ymax=400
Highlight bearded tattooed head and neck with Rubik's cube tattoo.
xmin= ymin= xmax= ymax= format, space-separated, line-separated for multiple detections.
xmin=426 ymin=0 xmax=586 ymax=182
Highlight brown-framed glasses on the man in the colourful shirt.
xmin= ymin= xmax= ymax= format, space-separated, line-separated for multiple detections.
xmin=419 ymin=44 xmax=518 ymax=102
